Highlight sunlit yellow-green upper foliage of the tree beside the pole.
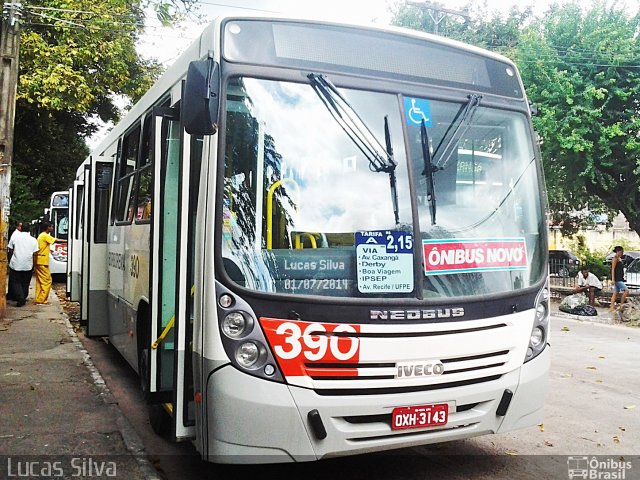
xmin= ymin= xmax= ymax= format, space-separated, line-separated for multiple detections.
xmin=17 ymin=0 xmax=160 ymax=121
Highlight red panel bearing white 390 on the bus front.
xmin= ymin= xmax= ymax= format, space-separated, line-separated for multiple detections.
xmin=260 ymin=318 xmax=360 ymax=376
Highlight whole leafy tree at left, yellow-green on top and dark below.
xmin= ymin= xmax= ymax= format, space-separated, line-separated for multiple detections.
xmin=11 ymin=0 xmax=194 ymax=225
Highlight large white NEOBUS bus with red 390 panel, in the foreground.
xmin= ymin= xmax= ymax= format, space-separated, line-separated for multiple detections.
xmin=70 ymin=17 xmax=550 ymax=463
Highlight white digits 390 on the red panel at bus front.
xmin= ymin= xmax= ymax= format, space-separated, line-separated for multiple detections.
xmin=274 ymin=322 xmax=360 ymax=362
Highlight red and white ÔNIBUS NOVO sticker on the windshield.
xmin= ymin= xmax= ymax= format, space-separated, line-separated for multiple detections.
xmin=422 ymin=238 xmax=527 ymax=275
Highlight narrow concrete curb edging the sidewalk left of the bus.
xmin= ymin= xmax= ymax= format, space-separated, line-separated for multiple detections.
xmin=54 ymin=308 xmax=162 ymax=480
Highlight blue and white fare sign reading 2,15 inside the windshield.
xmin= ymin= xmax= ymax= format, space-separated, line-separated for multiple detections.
xmin=356 ymin=230 xmax=413 ymax=293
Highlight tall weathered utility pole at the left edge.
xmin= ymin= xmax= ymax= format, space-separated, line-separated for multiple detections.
xmin=0 ymin=1 xmax=22 ymax=318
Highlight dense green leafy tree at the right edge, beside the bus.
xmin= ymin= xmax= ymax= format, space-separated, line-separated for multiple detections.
xmin=515 ymin=1 xmax=640 ymax=233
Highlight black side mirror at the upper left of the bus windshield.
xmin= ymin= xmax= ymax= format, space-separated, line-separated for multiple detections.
xmin=181 ymin=57 xmax=220 ymax=135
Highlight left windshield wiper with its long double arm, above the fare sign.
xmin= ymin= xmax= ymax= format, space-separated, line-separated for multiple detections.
xmin=307 ymin=73 xmax=400 ymax=225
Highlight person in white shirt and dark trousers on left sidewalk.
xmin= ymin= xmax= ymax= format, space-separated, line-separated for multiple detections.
xmin=8 ymin=223 xmax=38 ymax=307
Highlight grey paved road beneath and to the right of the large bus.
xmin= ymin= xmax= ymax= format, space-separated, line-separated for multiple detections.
xmin=81 ymin=317 xmax=640 ymax=480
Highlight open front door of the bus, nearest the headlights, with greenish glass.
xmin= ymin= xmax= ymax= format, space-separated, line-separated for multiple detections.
xmin=149 ymin=108 xmax=195 ymax=440
